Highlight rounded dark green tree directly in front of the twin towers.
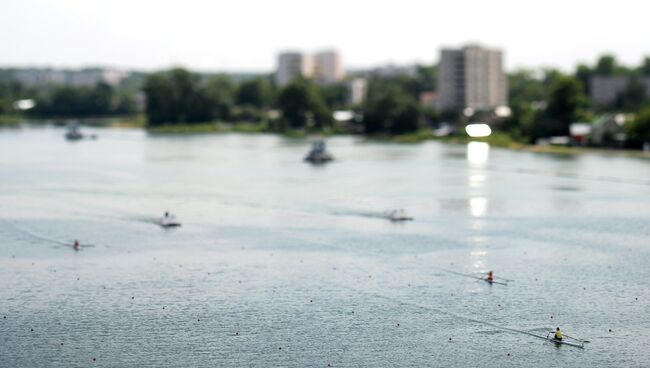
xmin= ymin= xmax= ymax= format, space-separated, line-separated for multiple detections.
xmin=278 ymin=79 xmax=333 ymax=129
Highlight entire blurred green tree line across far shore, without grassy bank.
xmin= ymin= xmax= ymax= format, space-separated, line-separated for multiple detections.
xmin=0 ymin=55 xmax=650 ymax=146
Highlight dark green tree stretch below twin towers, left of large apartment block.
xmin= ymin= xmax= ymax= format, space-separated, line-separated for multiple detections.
xmin=143 ymin=67 xmax=435 ymax=134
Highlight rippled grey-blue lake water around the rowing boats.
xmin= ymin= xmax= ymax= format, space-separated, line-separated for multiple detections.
xmin=0 ymin=126 xmax=650 ymax=367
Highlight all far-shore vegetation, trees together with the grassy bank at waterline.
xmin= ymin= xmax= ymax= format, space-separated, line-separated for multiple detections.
xmin=0 ymin=55 xmax=650 ymax=148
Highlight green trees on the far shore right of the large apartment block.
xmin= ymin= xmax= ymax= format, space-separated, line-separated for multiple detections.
xmin=500 ymin=55 xmax=650 ymax=147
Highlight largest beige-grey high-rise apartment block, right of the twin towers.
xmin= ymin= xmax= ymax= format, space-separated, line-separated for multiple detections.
xmin=436 ymin=46 xmax=508 ymax=111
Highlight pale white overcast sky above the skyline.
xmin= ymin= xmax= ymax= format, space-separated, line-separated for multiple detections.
xmin=0 ymin=0 xmax=650 ymax=72
